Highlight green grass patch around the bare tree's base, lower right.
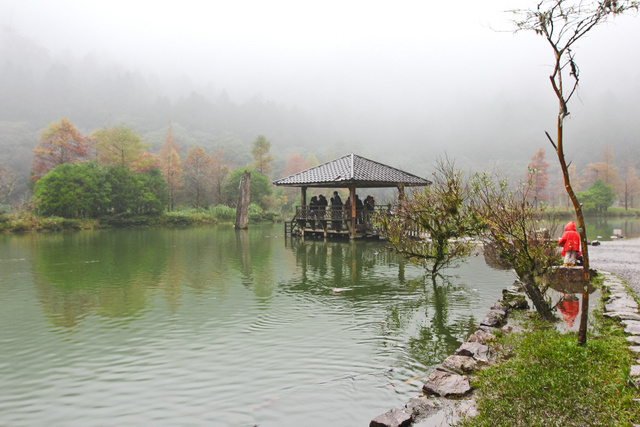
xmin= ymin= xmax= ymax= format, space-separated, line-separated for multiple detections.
xmin=460 ymin=312 xmax=640 ymax=427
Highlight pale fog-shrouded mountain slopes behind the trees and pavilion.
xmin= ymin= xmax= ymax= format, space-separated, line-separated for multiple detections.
xmin=0 ymin=26 xmax=640 ymax=201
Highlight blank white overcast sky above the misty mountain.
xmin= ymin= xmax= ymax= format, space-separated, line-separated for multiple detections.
xmin=0 ymin=0 xmax=640 ymax=101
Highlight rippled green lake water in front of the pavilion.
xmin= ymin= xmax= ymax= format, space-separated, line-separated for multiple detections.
xmin=0 ymin=224 xmax=514 ymax=427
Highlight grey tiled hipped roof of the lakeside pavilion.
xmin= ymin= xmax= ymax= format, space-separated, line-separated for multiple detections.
xmin=273 ymin=154 xmax=431 ymax=188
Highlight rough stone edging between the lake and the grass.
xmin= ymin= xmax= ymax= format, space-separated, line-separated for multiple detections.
xmin=369 ymin=286 xmax=529 ymax=427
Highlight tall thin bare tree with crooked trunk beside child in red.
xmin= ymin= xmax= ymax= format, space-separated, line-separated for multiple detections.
xmin=512 ymin=0 xmax=640 ymax=344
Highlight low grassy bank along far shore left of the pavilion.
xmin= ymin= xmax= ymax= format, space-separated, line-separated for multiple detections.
xmin=0 ymin=205 xmax=277 ymax=232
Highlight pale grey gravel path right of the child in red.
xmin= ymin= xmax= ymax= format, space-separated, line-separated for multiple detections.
xmin=589 ymin=239 xmax=640 ymax=296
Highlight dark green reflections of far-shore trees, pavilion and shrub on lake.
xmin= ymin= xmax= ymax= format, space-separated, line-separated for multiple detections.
xmin=33 ymin=229 xmax=507 ymax=372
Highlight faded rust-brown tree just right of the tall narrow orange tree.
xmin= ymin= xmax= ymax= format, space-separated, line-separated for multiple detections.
xmin=182 ymin=146 xmax=213 ymax=208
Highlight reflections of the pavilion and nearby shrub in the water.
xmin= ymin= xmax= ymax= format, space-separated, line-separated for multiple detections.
xmin=289 ymin=240 xmax=484 ymax=366
